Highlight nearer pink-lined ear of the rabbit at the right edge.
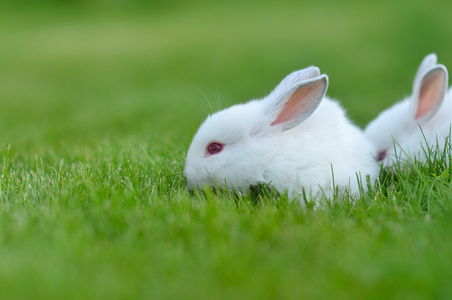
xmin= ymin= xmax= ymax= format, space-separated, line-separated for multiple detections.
xmin=411 ymin=65 xmax=448 ymax=121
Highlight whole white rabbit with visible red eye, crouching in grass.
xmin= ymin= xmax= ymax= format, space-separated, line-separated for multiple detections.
xmin=184 ymin=67 xmax=379 ymax=200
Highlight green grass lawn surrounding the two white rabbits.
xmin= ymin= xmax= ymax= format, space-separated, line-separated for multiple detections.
xmin=0 ymin=0 xmax=452 ymax=299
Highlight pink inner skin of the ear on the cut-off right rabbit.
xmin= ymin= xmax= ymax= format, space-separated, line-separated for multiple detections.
xmin=416 ymin=72 xmax=445 ymax=119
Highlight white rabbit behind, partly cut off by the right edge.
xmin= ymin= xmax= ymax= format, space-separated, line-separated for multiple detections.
xmin=364 ymin=54 xmax=452 ymax=166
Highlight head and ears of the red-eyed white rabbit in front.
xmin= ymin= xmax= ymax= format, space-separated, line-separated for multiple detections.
xmin=184 ymin=67 xmax=328 ymax=191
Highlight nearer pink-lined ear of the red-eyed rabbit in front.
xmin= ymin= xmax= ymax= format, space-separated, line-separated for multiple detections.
xmin=267 ymin=74 xmax=328 ymax=131
